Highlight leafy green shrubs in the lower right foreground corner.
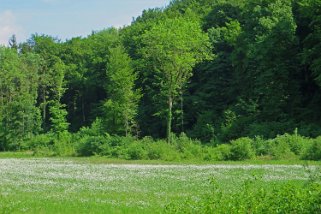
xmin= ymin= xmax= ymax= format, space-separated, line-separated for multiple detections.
xmin=166 ymin=178 xmax=321 ymax=214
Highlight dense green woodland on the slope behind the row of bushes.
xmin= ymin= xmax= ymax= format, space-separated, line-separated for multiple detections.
xmin=0 ymin=0 xmax=321 ymax=160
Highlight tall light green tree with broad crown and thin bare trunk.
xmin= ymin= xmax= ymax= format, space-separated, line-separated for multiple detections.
xmin=141 ymin=18 xmax=211 ymax=143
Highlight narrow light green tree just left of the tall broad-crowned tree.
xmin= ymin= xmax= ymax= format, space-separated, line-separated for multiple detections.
xmin=104 ymin=46 xmax=140 ymax=136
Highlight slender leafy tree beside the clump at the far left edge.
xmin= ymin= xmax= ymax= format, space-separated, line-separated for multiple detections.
xmin=31 ymin=35 xmax=68 ymax=133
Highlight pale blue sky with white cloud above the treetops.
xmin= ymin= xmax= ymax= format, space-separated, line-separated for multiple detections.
xmin=0 ymin=0 xmax=170 ymax=45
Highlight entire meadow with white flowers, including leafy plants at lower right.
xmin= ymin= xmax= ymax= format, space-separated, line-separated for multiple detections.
xmin=0 ymin=158 xmax=321 ymax=213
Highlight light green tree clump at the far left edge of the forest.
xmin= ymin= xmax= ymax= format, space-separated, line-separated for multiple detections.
xmin=0 ymin=47 xmax=40 ymax=150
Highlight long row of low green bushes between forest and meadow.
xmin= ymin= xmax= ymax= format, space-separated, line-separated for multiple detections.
xmin=18 ymin=129 xmax=320 ymax=162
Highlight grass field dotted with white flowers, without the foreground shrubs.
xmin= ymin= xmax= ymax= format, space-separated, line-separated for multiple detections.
xmin=0 ymin=158 xmax=317 ymax=213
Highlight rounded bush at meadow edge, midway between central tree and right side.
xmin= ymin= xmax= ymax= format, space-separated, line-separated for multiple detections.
xmin=231 ymin=137 xmax=255 ymax=160
